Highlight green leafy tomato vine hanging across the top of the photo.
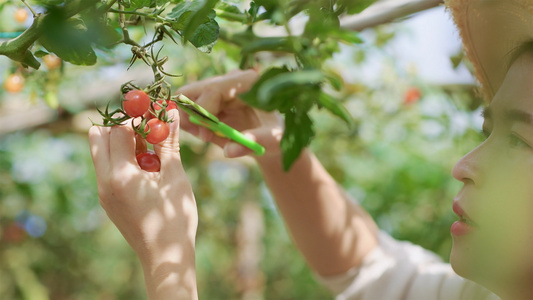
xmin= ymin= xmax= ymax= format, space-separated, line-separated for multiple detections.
xmin=0 ymin=0 xmax=375 ymax=169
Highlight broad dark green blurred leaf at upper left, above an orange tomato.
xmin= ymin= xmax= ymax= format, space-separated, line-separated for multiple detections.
xmin=39 ymin=9 xmax=96 ymax=65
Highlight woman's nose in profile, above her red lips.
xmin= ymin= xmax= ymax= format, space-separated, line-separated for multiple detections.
xmin=452 ymin=143 xmax=486 ymax=185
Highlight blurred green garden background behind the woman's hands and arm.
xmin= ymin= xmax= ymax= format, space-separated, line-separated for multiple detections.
xmin=0 ymin=2 xmax=481 ymax=300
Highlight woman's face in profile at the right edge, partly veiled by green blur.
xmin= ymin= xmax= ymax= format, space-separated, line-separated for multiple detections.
xmin=450 ymin=53 xmax=533 ymax=299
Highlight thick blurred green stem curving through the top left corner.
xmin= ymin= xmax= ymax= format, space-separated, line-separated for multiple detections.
xmin=0 ymin=0 xmax=100 ymax=69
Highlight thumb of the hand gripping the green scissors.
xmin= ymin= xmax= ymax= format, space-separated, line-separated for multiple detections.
xmin=224 ymin=127 xmax=283 ymax=158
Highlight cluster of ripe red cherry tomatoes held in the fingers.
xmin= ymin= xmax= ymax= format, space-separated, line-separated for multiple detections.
xmin=98 ymin=83 xmax=177 ymax=172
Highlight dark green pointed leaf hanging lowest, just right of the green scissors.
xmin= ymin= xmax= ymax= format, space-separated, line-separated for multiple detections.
xmin=280 ymin=110 xmax=315 ymax=171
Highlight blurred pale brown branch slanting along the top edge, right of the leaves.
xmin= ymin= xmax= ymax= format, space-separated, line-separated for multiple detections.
xmin=341 ymin=0 xmax=444 ymax=31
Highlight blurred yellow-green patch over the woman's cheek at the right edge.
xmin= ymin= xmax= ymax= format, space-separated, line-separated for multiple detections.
xmin=475 ymin=161 xmax=533 ymax=278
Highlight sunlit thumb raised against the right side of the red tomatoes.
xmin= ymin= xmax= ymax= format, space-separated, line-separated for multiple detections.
xmin=154 ymin=109 xmax=183 ymax=178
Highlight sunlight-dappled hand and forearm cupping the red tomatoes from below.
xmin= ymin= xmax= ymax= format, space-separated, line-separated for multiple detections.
xmin=89 ymin=110 xmax=198 ymax=299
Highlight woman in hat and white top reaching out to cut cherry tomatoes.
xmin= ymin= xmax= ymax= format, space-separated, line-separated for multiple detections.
xmin=89 ymin=0 xmax=533 ymax=300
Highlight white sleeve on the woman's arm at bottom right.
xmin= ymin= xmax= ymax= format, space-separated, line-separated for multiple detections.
xmin=317 ymin=232 xmax=499 ymax=300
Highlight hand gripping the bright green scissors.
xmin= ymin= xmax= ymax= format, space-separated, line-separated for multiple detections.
xmin=178 ymin=70 xmax=283 ymax=157
